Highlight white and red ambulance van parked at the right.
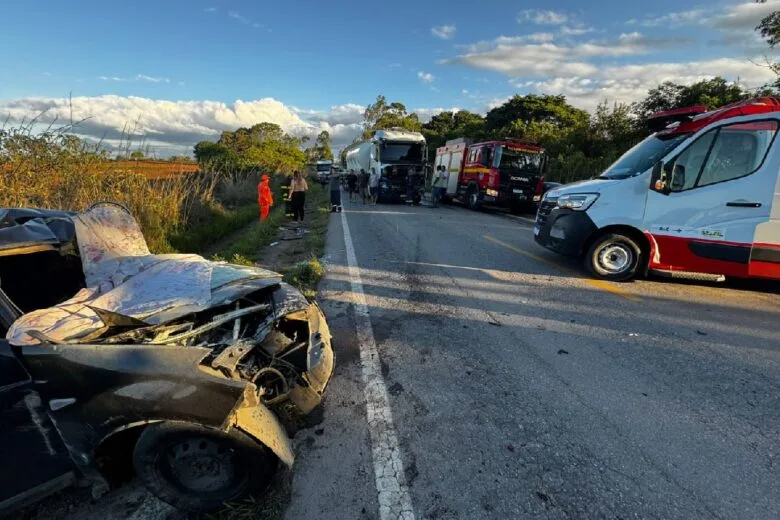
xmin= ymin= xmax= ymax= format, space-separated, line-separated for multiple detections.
xmin=534 ymin=97 xmax=780 ymax=281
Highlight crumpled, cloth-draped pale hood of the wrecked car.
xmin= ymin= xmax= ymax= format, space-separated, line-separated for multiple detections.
xmin=6 ymin=203 xmax=281 ymax=345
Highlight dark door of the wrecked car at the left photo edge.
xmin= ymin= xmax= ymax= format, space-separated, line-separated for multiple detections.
xmin=0 ymin=289 xmax=75 ymax=516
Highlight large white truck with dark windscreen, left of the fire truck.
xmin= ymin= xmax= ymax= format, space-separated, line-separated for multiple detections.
xmin=346 ymin=128 xmax=428 ymax=202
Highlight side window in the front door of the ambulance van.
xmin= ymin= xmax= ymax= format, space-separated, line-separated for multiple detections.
xmin=697 ymin=121 xmax=778 ymax=187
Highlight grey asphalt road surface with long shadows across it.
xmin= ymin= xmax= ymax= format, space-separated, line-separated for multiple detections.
xmin=287 ymin=197 xmax=780 ymax=520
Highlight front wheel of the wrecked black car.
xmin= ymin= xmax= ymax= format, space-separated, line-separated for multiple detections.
xmin=133 ymin=423 xmax=278 ymax=512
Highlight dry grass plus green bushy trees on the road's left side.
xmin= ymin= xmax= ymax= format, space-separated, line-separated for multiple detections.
xmin=0 ymin=120 xmax=305 ymax=253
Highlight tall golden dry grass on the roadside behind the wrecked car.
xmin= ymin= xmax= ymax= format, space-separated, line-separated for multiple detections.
xmin=0 ymin=127 xmax=268 ymax=253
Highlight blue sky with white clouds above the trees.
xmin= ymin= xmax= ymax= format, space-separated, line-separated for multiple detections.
xmin=0 ymin=0 xmax=780 ymax=156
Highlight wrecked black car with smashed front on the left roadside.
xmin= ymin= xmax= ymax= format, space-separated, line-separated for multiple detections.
xmin=0 ymin=203 xmax=334 ymax=514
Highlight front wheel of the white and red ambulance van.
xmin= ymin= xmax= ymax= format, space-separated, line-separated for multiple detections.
xmin=585 ymin=233 xmax=642 ymax=282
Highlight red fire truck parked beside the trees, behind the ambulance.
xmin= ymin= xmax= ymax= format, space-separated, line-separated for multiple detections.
xmin=434 ymin=138 xmax=545 ymax=211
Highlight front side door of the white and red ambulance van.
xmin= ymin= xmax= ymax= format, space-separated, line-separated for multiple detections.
xmin=644 ymin=119 xmax=778 ymax=276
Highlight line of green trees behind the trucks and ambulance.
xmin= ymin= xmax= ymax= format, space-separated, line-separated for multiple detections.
xmin=195 ymin=8 xmax=780 ymax=182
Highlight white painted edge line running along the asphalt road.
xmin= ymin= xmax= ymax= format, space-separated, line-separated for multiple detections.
xmin=341 ymin=212 xmax=414 ymax=520
